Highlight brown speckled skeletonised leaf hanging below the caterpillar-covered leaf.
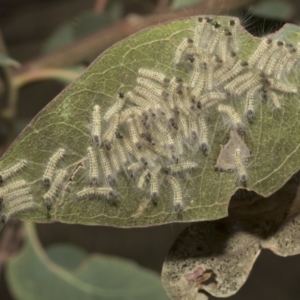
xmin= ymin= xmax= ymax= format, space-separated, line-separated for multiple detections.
xmin=162 ymin=174 xmax=300 ymax=300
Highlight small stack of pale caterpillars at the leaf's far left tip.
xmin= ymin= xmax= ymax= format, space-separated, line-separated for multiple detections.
xmin=0 ymin=160 xmax=36 ymax=224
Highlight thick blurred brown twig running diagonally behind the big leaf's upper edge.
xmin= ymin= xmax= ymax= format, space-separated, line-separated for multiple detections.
xmin=15 ymin=0 xmax=257 ymax=75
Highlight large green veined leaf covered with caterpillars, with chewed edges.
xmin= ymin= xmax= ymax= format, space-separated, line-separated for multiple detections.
xmin=0 ymin=17 xmax=300 ymax=227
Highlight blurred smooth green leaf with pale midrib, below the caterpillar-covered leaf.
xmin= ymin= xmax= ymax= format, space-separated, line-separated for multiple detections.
xmin=6 ymin=224 xmax=167 ymax=300
